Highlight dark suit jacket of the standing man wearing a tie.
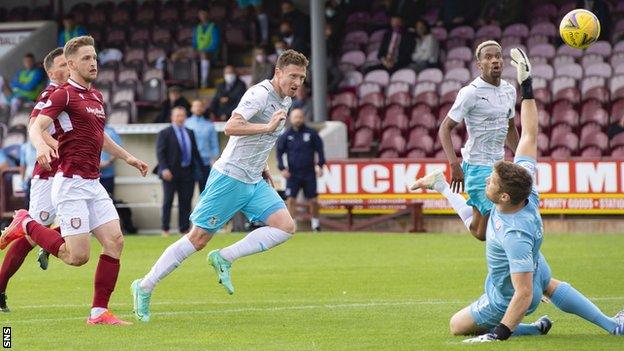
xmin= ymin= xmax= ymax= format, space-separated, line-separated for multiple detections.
xmin=154 ymin=126 xmax=201 ymax=181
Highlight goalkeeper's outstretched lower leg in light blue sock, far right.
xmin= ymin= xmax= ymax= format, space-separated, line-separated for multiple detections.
xmin=546 ymin=279 xmax=624 ymax=335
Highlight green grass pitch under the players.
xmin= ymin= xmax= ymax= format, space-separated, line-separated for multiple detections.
xmin=0 ymin=233 xmax=624 ymax=351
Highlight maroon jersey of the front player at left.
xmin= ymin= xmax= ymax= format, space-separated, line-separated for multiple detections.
xmin=40 ymin=79 xmax=106 ymax=179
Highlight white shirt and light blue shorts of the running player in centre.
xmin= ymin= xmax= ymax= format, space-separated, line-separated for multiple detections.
xmin=191 ymin=80 xmax=292 ymax=233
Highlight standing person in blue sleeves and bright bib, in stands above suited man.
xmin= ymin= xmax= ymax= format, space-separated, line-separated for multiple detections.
xmin=193 ymin=9 xmax=221 ymax=88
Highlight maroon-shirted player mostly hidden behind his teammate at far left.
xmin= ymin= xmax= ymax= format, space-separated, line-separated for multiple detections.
xmin=0 ymin=48 xmax=69 ymax=312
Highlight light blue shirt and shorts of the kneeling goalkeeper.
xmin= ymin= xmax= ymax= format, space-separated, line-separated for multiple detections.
xmin=471 ymin=157 xmax=550 ymax=327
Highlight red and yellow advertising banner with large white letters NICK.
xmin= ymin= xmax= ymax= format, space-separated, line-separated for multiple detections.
xmin=318 ymin=159 xmax=624 ymax=214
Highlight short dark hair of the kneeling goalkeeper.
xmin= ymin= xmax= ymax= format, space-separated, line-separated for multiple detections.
xmin=494 ymin=161 xmax=533 ymax=205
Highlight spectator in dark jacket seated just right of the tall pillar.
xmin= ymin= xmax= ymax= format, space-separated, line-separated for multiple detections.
xmin=374 ymin=16 xmax=414 ymax=72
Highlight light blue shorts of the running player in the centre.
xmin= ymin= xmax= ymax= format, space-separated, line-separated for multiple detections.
xmin=191 ymin=168 xmax=286 ymax=233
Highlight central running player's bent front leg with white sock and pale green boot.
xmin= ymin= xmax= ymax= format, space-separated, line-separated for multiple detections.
xmin=208 ymin=181 xmax=295 ymax=294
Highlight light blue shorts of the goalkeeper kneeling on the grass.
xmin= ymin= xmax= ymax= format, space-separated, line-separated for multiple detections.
xmin=470 ymin=254 xmax=551 ymax=330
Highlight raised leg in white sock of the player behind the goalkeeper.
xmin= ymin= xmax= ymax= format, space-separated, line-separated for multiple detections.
xmin=410 ymin=170 xmax=473 ymax=234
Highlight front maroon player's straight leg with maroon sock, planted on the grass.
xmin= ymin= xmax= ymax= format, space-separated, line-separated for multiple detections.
xmin=87 ymin=187 xmax=131 ymax=325
